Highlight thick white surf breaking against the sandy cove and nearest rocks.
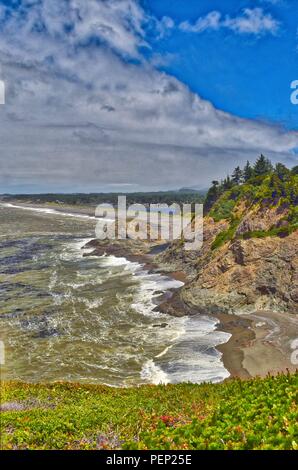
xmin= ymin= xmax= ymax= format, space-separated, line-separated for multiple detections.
xmin=127 ymin=260 xmax=231 ymax=384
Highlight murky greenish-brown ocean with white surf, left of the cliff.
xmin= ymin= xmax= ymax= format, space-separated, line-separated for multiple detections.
xmin=0 ymin=203 xmax=230 ymax=387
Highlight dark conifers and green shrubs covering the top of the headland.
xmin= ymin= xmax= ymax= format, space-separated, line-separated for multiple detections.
xmin=205 ymin=155 xmax=298 ymax=250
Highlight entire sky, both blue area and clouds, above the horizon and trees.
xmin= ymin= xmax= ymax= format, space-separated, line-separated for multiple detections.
xmin=0 ymin=0 xmax=298 ymax=193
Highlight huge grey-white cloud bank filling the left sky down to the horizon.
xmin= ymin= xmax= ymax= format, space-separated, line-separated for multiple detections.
xmin=0 ymin=0 xmax=298 ymax=192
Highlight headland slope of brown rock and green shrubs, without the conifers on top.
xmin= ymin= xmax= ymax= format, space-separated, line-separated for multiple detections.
xmin=159 ymin=162 xmax=298 ymax=313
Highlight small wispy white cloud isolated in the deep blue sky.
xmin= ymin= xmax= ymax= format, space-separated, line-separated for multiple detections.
xmin=179 ymin=8 xmax=280 ymax=36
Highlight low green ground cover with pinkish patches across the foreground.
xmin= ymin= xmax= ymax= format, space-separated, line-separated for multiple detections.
xmin=1 ymin=373 xmax=298 ymax=450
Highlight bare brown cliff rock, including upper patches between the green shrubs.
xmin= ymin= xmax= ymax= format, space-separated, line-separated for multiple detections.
xmin=159 ymin=203 xmax=298 ymax=314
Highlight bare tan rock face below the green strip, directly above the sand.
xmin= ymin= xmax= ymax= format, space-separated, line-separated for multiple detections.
xmin=181 ymin=232 xmax=298 ymax=313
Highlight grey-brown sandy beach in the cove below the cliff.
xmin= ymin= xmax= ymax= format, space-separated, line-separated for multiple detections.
xmin=217 ymin=311 xmax=298 ymax=378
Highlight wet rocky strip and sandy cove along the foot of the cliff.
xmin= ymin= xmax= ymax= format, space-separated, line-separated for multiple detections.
xmin=84 ymin=240 xmax=298 ymax=379
